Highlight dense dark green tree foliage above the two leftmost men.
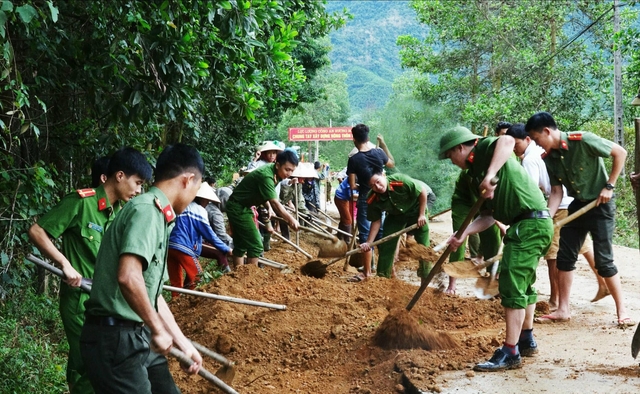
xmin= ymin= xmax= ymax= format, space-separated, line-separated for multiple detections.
xmin=0 ymin=0 xmax=345 ymax=292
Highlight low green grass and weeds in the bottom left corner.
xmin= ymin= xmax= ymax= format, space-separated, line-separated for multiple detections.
xmin=0 ymin=289 xmax=69 ymax=394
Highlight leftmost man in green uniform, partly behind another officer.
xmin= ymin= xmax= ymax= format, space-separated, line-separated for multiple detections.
xmin=29 ymin=148 xmax=151 ymax=393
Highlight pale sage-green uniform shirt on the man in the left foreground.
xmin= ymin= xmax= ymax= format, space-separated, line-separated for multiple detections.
xmin=85 ymin=187 xmax=175 ymax=322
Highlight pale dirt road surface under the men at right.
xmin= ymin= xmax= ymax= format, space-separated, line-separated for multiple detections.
xmin=424 ymin=218 xmax=640 ymax=393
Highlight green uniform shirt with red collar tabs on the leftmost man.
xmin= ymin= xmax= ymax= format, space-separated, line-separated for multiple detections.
xmin=37 ymin=185 xmax=120 ymax=294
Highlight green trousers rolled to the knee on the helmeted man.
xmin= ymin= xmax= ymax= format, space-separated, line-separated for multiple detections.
xmin=498 ymin=218 xmax=553 ymax=309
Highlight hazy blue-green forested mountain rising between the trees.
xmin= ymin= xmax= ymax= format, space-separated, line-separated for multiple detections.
xmin=327 ymin=1 xmax=425 ymax=117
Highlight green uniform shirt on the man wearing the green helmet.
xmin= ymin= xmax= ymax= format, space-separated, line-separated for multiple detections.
xmin=467 ymin=137 xmax=547 ymax=224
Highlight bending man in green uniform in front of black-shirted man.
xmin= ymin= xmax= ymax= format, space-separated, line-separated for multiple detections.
xmin=360 ymin=170 xmax=431 ymax=278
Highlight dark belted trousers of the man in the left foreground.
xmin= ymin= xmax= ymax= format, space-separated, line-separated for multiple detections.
xmin=81 ymin=324 xmax=180 ymax=394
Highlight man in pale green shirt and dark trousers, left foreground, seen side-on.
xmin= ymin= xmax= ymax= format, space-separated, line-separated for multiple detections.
xmin=80 ymin=144 xmax=204 ymax=393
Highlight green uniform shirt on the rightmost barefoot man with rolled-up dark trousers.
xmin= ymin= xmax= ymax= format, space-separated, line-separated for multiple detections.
xmin=544 ymin=131 xmax=613 ymax=201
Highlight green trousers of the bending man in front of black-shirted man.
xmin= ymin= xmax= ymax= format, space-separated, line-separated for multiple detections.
xmin=377 ymin=214 xmax=431 ymax=278
